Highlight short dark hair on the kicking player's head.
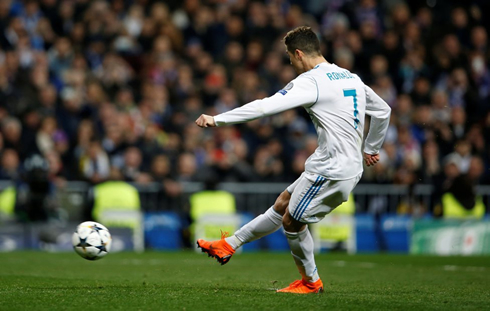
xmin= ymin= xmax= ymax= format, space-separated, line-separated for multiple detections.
xmin=284 ymin=26 xmax=321 ymax=56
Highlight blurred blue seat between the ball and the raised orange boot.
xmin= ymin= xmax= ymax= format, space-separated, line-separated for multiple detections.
xmin=144 ymin=212 xmax=182 ymax=250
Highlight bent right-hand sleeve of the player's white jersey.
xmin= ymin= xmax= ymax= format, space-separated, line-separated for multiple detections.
xmin=364 ymin=85 xmax=391 ymax=154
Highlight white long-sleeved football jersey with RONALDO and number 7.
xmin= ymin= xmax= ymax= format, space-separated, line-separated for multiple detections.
xmin=214 ymin=63 xmax=391 ymax=180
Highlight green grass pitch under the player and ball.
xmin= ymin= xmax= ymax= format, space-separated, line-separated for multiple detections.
xmin=0 ymin=251 xmax=490 ymax=311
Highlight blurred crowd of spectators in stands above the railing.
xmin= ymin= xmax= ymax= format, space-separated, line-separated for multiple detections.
xmin=0 ymin=0 xmax=490 ymax=214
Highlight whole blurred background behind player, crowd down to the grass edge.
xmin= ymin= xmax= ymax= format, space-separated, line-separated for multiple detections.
xmin=0 ymin=0 xmax=490 ymax=254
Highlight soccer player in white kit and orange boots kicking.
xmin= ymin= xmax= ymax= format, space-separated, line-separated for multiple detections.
xmin=196 ymin=26 xmax=391 ymax=294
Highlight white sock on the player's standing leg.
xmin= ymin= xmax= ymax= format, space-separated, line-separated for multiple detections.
xmin=286 ymin=227 xmax=320 ymax=283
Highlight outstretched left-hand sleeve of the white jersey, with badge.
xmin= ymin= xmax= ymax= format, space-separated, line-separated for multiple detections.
xmin=214 ymin=76 xmax=318 ymax=126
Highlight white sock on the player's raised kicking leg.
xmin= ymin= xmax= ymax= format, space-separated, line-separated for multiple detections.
xmin=225 ymin=206 xmax=282 ymax=250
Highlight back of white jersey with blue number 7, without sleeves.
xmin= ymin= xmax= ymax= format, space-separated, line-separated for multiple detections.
xmin=298 ymin=63 xmax=366 ymax=180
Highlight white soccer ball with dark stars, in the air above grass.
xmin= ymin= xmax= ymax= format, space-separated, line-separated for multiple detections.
xmin=71 ymin=221 xmax=112 ymax=260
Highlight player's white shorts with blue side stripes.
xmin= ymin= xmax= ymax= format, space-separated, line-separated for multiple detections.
xmin=287 ymin=172 xmax=362 ymax=223
